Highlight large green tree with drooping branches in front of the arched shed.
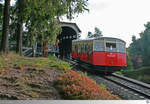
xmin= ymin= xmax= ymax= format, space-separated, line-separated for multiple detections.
xmin=14 ymin=0 xmax=88 ymax=53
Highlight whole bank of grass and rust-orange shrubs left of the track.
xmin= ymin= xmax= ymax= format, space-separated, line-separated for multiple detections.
xmin=0 ymin=53 xmax=119 ymax=100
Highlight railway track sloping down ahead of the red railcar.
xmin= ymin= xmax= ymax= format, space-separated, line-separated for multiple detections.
xmin=104 ymin=74 xmax=150 ymax=99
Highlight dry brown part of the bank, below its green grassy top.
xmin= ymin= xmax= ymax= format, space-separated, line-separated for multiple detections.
xmin=0 ymin=58 xmax=61 ymax=100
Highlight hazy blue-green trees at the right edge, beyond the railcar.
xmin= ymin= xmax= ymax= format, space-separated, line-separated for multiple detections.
xmin=129 ymin=22 xmax=150 ymax=68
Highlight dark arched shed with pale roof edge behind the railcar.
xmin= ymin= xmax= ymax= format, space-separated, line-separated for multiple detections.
xmin=57 ymin=22 xmax=81 ymax=57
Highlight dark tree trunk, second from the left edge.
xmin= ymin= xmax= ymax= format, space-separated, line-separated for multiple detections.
xmin=16 ymin=0 xmax=23 ymax=56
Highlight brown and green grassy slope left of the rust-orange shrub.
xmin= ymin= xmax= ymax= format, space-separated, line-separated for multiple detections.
xmin=0 ymin=52 xmax=71 ymax=100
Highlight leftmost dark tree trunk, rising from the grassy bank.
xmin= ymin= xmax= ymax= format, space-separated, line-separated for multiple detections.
xmin=0 ymin=0 xmax=10 ymax=54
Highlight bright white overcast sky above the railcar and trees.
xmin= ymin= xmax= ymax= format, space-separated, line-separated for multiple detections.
xmin=64 ymin=0 xmax=150 ymax=46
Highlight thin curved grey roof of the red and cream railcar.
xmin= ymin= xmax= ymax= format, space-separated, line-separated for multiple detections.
xmin=73 ymin=37 xmax=126 ymax=43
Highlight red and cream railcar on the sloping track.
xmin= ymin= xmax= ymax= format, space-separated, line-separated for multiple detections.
xmin=72 ymin=37 xmax=127 ymax=72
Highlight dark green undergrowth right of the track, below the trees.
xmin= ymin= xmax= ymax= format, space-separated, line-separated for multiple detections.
xmin=123 ymin=67 xmax=150 ymax=84
